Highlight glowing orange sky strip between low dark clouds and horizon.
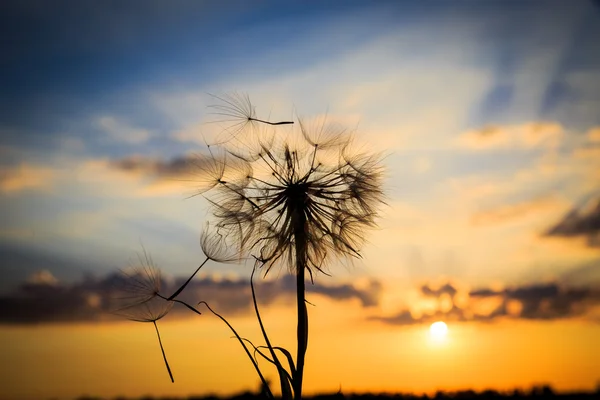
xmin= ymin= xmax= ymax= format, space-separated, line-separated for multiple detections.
xmin=0 ymin=296 xmax=600 ymax=400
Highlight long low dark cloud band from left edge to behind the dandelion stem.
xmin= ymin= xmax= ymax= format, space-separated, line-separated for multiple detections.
xmin=0 ymin=272 xmax=381 ymax=324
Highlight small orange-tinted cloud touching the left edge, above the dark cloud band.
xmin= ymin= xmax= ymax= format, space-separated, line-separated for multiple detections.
xmin=0 ymin=163 xmax=56 ymax=193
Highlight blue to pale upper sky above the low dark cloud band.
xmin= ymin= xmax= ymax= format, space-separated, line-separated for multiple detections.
xmin=0 ymin=1 xmax=600 ymax=310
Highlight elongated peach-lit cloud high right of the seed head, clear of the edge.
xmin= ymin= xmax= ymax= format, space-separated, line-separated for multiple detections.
xmin=458 ymin=121 xmax=564 ymax=150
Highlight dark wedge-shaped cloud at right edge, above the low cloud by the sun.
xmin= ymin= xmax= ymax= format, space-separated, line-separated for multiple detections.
xmin=545 ymin=198 xmax=600 ymax=246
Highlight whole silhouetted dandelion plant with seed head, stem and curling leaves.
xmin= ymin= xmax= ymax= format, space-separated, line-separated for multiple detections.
xmin=112 ymin=94 xmax=383 ymax=399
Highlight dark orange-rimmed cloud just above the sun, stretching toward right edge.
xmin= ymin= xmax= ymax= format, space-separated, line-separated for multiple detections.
xmin=369 ymin=282 xmax=600 ymax=325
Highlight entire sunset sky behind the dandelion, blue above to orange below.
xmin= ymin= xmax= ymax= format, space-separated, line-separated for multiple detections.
xmin=0 ymin=0 xmax=600 ymax=400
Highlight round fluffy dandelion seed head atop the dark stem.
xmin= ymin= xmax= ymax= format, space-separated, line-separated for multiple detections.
xmin=195 ymin=95 xmax=384 ymax=276
